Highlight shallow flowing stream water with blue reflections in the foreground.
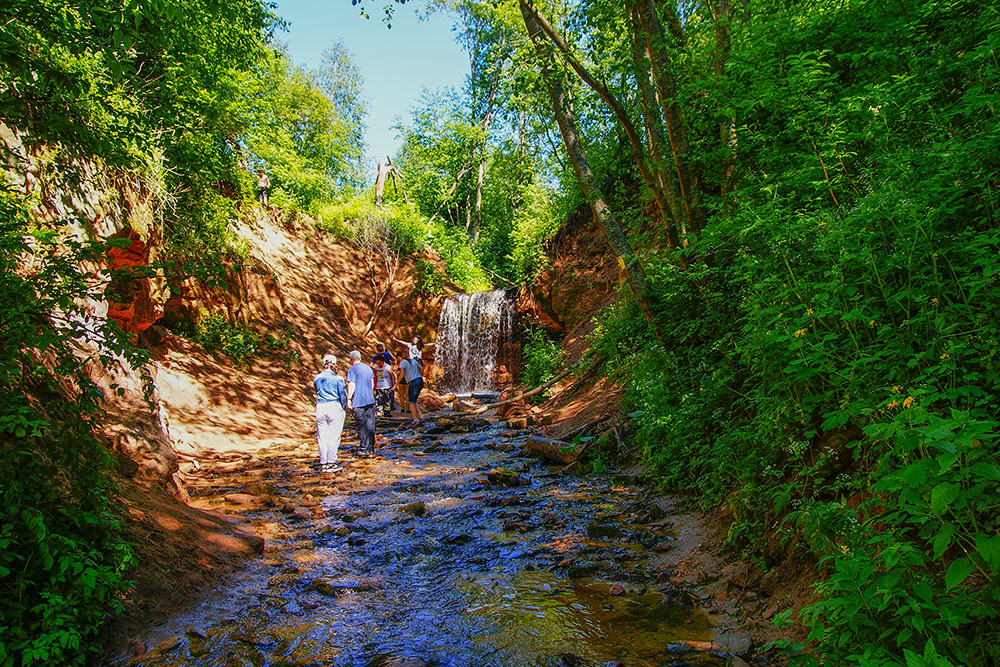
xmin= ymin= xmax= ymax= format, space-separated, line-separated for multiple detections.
xmin=109 ymin=430 xmax=725 ymax=667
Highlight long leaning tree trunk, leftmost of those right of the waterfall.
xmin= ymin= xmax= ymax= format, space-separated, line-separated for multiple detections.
xmin=520 ymin=5 xmax=664 ymax=343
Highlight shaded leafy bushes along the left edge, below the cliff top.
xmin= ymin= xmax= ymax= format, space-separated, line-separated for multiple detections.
xmin=0 ymin=186 xmax=144 ymax=665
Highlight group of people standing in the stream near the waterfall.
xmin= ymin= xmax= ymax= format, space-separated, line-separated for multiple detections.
xmin=313 ymin=336 xmax=434 ymax=472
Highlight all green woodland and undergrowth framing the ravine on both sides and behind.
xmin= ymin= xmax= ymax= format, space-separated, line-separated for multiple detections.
xmin=0 ymin=0 xmax=1000 ymax=667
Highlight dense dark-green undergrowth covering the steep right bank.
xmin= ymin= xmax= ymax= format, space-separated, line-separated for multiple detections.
xmin=594 ymin=1 xmax=1000 ymax=665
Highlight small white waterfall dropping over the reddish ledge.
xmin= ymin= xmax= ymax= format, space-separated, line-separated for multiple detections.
xmin=434 ymin=289 xmax=513 ymax=394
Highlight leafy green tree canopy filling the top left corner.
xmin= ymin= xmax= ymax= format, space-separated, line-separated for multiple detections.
xmin=0 ymin=0 xmax=275 ymax=257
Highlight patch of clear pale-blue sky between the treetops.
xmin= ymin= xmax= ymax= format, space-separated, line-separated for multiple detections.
xmin=276 ymin=0 xmax=469 ymax=179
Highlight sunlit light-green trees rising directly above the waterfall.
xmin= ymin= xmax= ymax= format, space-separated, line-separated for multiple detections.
xmin=395 ymin=20 xmax=561 ymax=285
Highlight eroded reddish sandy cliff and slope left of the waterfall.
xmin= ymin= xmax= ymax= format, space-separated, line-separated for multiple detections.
xmin=0 ymin=124 xmax=454 ymax=499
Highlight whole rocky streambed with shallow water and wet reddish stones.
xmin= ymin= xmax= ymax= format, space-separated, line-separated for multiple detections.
xmin=106 ymin=415 xmax=773 ymax=667
